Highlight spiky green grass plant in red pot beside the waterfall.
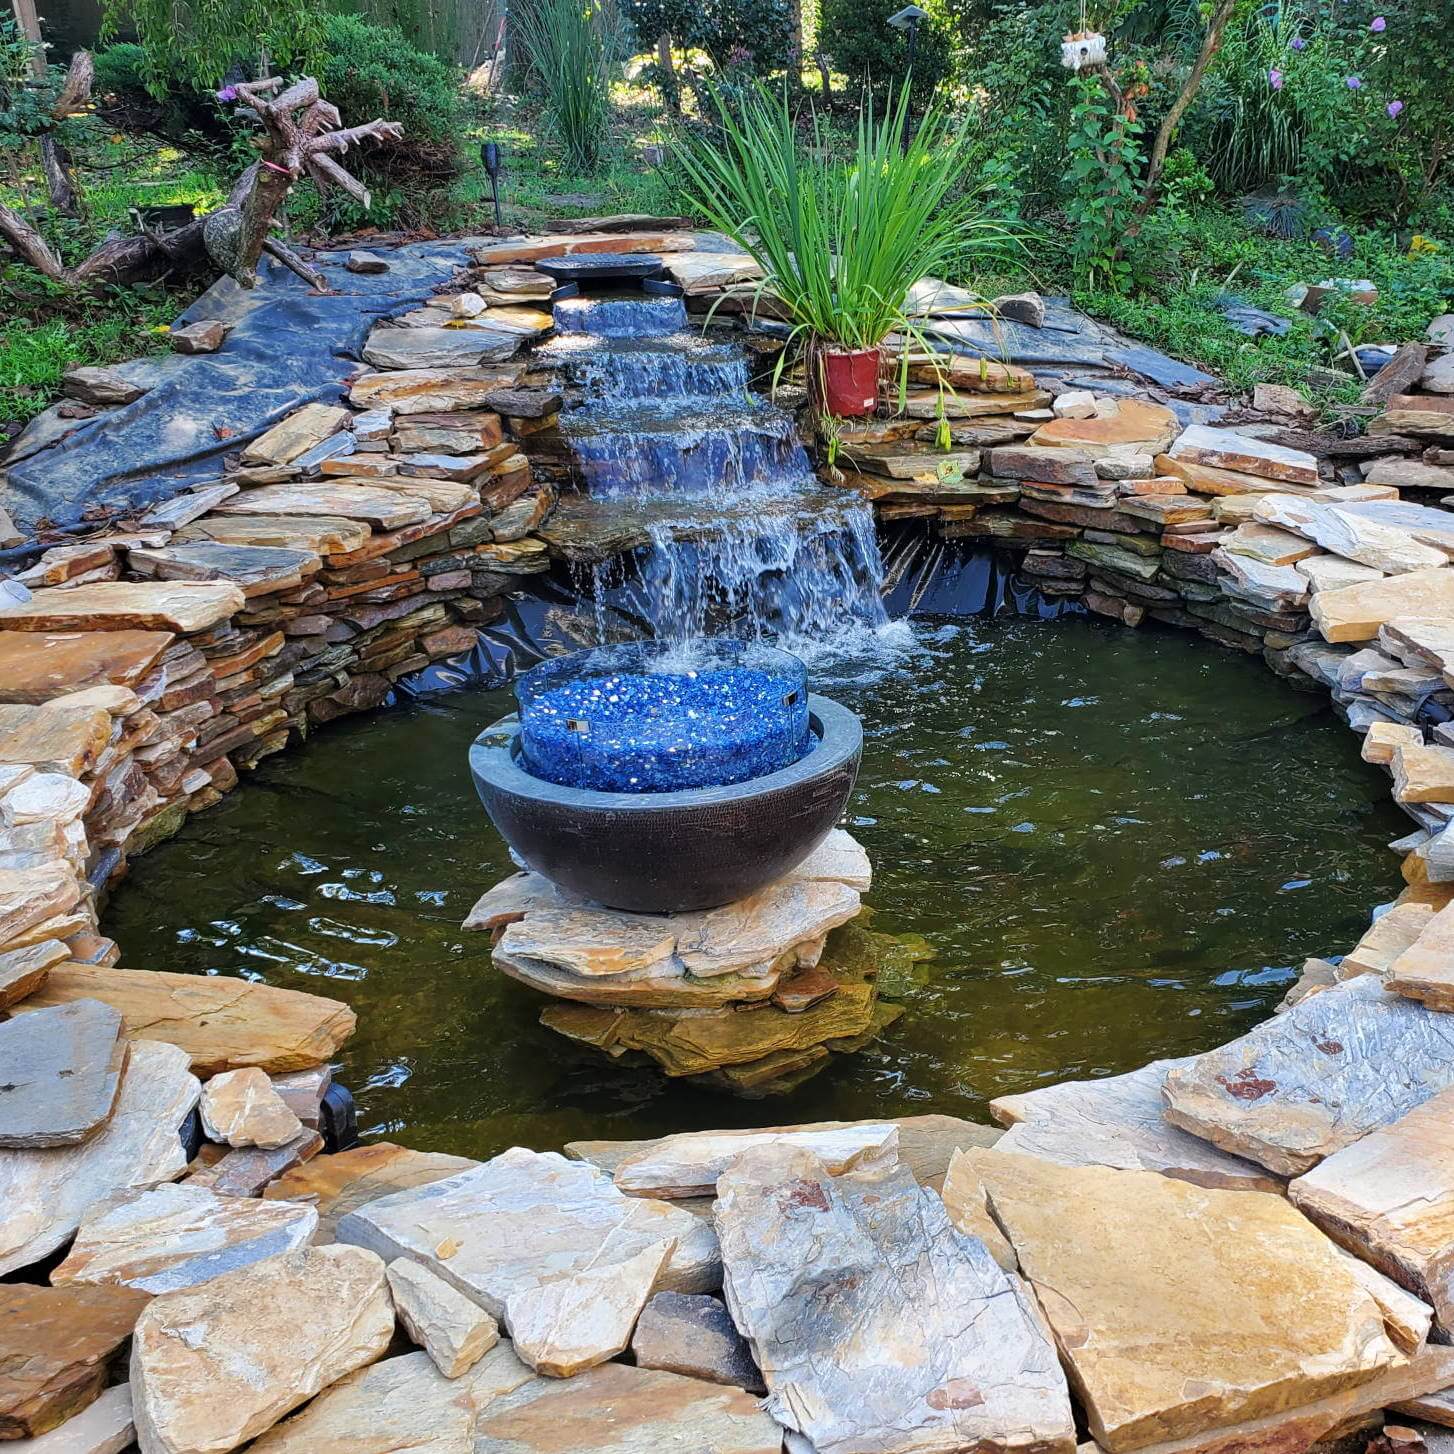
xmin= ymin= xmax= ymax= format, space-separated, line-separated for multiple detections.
xmin=676 ymin=84 xmax=1016 ymax=417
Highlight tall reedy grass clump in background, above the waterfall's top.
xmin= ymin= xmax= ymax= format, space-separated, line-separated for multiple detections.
xmin=510 ymin=0 xmax=625 ymax=172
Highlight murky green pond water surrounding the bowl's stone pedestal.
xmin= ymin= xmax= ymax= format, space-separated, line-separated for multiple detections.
xmin=106 ymin=618 xmax=1406 ymax=1156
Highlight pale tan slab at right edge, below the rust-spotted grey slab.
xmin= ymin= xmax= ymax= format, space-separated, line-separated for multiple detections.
xmin=1288 ymin=1091 xmax=1454 ymax=1341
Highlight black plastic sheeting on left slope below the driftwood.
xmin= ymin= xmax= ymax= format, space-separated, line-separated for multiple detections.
xmin=0 ymin=241 xmax=468 ymax=532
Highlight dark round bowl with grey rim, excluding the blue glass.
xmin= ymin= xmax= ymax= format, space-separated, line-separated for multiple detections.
xmin=470 ymin=695 xmax=864 ymax=913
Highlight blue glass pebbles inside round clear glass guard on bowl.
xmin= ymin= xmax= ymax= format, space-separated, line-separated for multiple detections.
xmin=515 ymin=641 xmax=810 ymax=792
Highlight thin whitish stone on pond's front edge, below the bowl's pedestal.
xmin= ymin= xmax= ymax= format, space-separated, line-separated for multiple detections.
xmin=614 ymin=1121 xmax=899 ymax=1200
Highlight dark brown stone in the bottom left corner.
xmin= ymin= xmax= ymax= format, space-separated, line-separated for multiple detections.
xmin=0 ymin=1282 xmax=147 ymax=1442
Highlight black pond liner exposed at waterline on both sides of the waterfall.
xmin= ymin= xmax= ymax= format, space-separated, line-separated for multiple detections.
xmin=394 ymin=522 xmax=1085 ymax=699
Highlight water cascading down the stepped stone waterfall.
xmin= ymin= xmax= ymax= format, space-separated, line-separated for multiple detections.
xmin=547 ymin=295 xmax=887 ymax=651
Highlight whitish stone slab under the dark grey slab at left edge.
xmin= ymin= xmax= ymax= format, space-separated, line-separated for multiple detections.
xmin=0 ymin=1040 xmax=201 ymax=1274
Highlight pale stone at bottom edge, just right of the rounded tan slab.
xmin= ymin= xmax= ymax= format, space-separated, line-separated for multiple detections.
xmin=249 ymin=1343 xmax=532 ymax=1454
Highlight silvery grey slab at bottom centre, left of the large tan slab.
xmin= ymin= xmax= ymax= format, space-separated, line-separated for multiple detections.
xmin=715 ymin=1144 xmax=1075 ymax=1454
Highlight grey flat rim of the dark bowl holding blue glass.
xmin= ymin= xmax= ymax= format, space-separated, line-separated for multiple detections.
xmin=470 ymin=692 xmax=864 ymax=813
